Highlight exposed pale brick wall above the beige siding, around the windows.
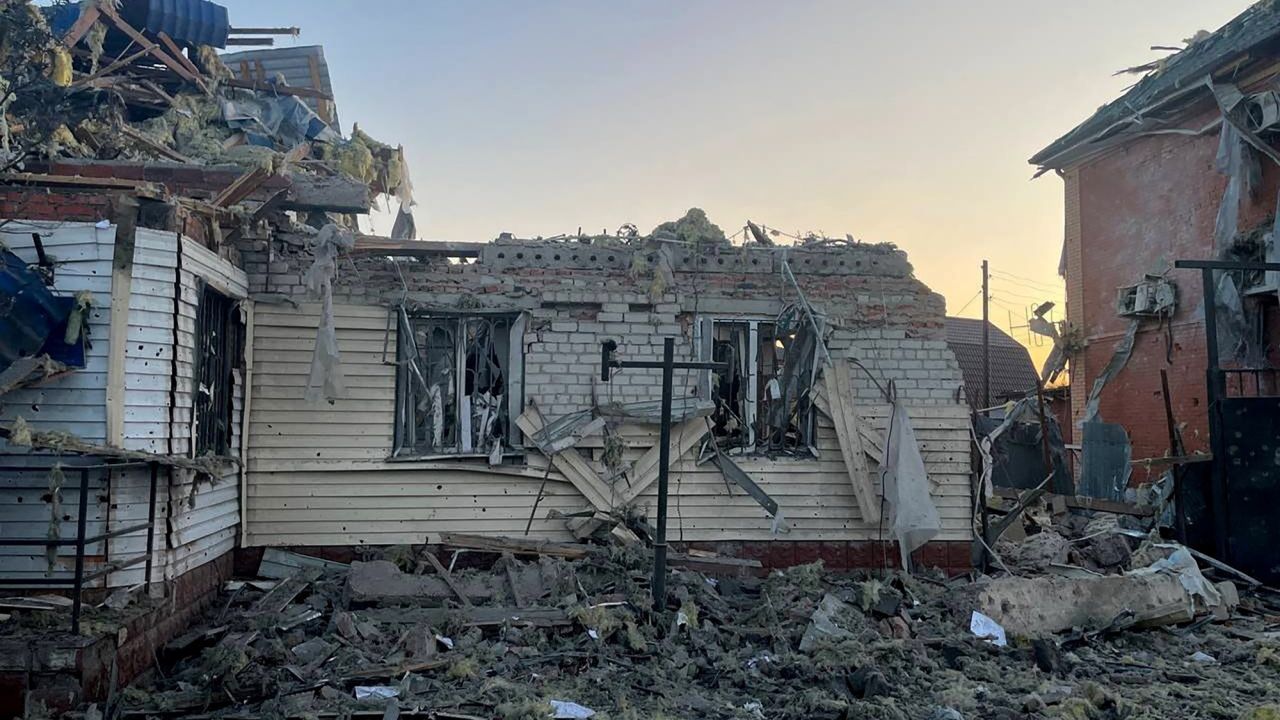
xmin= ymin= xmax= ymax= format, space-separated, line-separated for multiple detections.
xmin=239 ymin=236 xmax=960 ymax=415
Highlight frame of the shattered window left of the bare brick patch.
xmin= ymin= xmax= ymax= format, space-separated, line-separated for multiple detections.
xmin=388 ymin=307 xmax=529 ymax=453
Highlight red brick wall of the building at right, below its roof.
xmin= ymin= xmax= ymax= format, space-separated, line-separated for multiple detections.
xmin=1066 ymin=113 xmax=1280 ymax=458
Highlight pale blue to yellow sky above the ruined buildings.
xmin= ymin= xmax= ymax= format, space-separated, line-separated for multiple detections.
xmin=220 ymin=0 xmax=1249 ymax=359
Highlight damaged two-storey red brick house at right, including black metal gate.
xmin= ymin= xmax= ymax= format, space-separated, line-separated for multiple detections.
xmin=1030 ymin=3 xmax=1280 ymax=578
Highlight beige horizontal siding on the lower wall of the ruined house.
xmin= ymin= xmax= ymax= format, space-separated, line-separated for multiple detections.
xmin=246 ymin=302 xmax=972 ymax=546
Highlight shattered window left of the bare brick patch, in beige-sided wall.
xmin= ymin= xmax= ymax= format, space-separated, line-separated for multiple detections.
xmin=393 ymin=311 xmax=525 ymax=461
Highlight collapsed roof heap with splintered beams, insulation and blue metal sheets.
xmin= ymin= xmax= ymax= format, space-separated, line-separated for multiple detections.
xmin=0 ymin=0 xmax=413 ymax=224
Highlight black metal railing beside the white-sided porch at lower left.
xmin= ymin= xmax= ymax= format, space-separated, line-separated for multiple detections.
xmin=0 ymin=461 xmax=160 ymax=634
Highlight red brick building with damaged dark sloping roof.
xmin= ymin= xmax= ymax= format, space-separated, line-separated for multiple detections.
xmin=1030 ymin=3 xmax=1280 ymax=461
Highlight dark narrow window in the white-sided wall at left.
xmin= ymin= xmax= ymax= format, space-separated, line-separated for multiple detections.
xmin=192 ymin=284 xmax=244 ymax=457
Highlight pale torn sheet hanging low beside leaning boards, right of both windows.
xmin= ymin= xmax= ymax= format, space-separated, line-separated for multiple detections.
xmin=883 ymin=389 xmax=942 ymax=568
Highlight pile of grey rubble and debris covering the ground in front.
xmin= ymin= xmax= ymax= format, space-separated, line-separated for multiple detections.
xmin=80 ymin=530 xmax=1280 ymax=720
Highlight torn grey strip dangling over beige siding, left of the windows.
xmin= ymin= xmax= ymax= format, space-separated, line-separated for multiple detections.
xmin=302 ymin=223 xmax=356 ymax=402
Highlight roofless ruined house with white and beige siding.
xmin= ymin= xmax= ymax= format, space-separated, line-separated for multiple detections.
xmin=0 ymin=1 xmax=973 ymax=712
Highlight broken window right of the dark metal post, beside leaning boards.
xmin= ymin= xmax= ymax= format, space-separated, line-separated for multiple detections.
xmin=701 ymin=319 xmax=815 ymax=454
